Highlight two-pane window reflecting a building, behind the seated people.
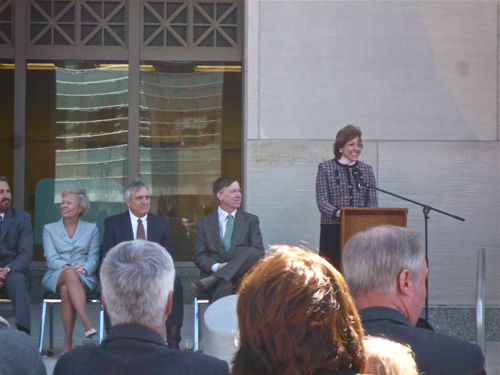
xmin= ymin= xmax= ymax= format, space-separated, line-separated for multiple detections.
xmin=25 ymin=61 xmax=242 ymax=261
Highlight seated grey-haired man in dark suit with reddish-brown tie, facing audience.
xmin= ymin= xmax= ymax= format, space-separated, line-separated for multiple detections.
xmin=102 ymin=180 xmax=184 ymax=349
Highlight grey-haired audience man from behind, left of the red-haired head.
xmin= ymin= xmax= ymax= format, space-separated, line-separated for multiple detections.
xmin=54 ymin=240 xmax=229 ymax=375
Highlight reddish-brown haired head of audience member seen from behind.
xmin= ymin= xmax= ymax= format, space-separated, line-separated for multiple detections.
xmin=232 ymin=245 xmax=365 ymax=375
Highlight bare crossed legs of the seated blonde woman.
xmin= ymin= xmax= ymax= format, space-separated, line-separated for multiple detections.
xmin=56 ymin=268 xmax=93 ymax=353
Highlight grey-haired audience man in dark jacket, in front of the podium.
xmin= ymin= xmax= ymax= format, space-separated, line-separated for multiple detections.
xmin=343 ymin=225 xmax=486 ymax=375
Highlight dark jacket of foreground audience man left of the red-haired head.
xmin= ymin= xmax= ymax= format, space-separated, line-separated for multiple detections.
xmin=54 ymin=324 xmax=229 ymax=375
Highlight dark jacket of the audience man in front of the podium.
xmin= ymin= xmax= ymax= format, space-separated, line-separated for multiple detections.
xmin=359 ymin=307 xmax=486 ymax=375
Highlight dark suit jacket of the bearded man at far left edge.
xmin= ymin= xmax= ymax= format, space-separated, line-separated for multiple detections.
xmin=0 ymin=207 xmax=33 ymax=277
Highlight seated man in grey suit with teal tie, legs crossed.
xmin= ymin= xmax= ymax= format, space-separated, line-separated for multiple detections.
xmin=192 ymin=177 xmax=264 ymax=303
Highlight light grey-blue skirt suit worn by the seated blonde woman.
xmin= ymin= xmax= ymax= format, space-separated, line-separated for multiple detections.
xmin=42 ymin=219 xmax=100 ymax=293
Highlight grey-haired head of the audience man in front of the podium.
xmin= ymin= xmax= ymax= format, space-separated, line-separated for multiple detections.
xmin=343 ymin=225 xmax=428 ymax=325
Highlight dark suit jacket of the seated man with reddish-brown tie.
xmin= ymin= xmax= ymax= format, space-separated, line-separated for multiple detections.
xmin=102 ymin=211 xmax=175 ymax=259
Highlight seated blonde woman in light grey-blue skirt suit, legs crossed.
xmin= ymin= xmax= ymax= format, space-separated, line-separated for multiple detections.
xmin=42 ymin=188 xmax=99 ymax=353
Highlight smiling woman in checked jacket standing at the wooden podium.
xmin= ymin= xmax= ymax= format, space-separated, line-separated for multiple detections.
xmin=316 ymin=125 xmax=377 ymax=270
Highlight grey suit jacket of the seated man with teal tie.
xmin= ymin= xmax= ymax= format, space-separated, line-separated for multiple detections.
xmin=194 ymin=210 xmax=264 ymax=277
